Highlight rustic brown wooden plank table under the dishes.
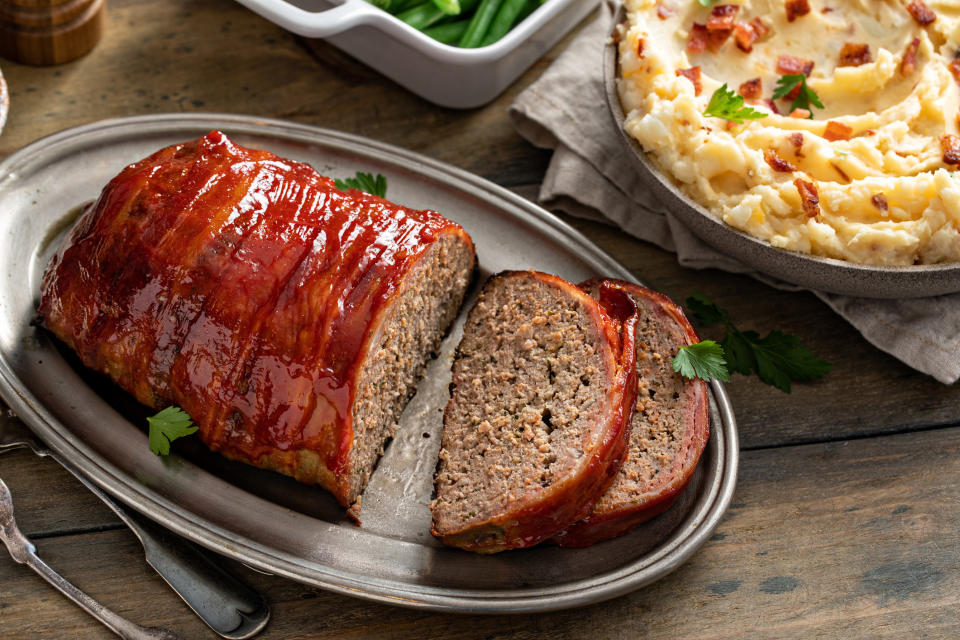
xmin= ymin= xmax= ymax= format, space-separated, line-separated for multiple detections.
xmin=0 ymin=0 xmax=960 ymax=640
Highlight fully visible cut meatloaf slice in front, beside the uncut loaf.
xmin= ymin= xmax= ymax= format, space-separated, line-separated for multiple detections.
xmin=431 ymin=271 xmax=636 ymax=553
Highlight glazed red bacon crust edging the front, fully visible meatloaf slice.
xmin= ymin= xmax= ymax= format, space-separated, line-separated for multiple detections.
xmin=431 ymin=271 xmax=637 ymax=553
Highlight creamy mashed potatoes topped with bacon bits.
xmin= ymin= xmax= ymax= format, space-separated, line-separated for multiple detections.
xmin=618 ymin=0 xmax=960 ymax=265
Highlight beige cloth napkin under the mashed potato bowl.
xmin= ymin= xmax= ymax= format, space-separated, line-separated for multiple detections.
xmin=510 ymin=4 xmax=960 ymax=384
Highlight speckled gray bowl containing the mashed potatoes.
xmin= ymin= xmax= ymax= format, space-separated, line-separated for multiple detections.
xmin=603 ymin=6 xmax=960 ymax=298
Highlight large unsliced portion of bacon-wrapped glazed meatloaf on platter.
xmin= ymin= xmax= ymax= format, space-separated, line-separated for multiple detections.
xmin=39 ymin=132 xmax=475 ymax=505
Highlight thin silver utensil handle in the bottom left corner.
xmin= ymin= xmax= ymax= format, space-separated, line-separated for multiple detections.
xmin=0 ymin=479 xmax=177 ymax=640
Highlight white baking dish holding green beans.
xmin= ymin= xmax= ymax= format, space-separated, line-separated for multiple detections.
xmin=237 ymin=0 xmax=599 ymax=109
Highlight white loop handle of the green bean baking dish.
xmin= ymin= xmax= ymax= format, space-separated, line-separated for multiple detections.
xmin=237 ymin=0 xmax=386 ymax=38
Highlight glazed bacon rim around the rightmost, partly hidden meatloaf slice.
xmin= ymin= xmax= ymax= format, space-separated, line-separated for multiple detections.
xmin=553 ymin=279 xmax=710 ymax=547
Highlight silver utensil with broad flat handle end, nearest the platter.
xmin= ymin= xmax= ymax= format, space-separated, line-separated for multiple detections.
xmin=0 ymin=416 xmax=270 ymax=640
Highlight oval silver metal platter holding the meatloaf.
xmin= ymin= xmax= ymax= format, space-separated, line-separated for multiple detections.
xmin=0 ymin=114 xmax=738 ymax=613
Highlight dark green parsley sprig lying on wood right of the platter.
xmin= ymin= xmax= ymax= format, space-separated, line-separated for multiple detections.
xmin=674 ymin=293 xmax=833 ymax=393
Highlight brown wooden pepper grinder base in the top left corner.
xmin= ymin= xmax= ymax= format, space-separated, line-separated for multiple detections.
xmin=0 ymin=0 xmax=106 ymax=65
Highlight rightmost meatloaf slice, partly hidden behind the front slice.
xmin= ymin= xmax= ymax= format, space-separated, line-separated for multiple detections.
xmin=554 ymin=280 xmax=710 ymax=547
